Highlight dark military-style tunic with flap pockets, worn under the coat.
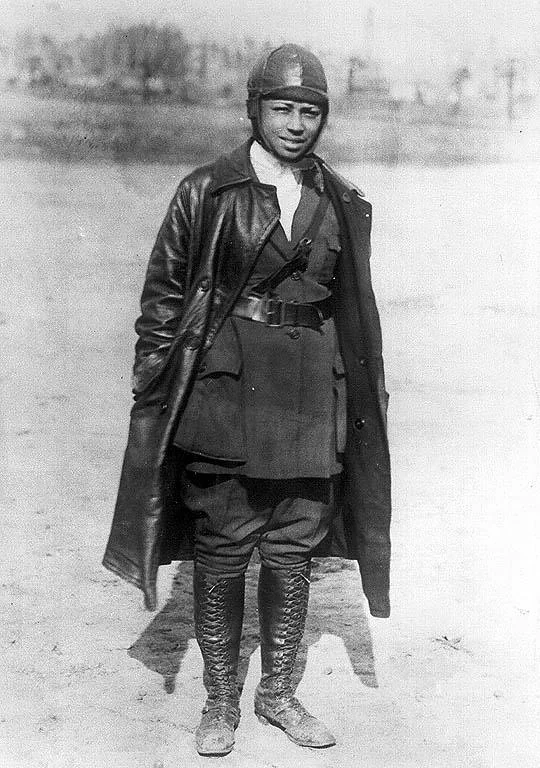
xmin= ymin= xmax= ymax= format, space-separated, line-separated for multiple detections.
xmin=175 ymin=165 xmax=345 ymax=478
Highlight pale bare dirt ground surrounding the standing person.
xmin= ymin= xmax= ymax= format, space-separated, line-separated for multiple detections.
xmin=0 ymin=153 xmax=540 ymax=768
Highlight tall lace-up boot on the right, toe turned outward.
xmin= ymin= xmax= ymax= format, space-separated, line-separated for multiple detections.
xmin=255 ymin=563 xmax=336 ymax=747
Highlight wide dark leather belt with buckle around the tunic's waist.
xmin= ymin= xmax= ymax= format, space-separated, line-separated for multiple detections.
xmin=232 ymin=296 xmax=332 ymax=331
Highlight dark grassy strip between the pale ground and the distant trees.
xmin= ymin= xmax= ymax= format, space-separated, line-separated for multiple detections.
xmin=0 ymin=92 xmax=540 ymax=166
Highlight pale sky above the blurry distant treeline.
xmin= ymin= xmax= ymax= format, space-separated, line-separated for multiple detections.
xmin=0 ymin=0 xmax=540 ymax=77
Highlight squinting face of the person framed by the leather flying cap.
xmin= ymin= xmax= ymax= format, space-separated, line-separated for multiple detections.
xmin=259 ymin=99 xmax=323 ymax=163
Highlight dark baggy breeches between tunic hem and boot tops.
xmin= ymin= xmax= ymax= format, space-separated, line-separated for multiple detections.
xmin=181 ymin=471 xmax=332 ymax=576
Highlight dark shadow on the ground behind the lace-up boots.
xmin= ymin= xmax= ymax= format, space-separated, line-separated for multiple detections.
xmin=129 ymin=558 xmax=377 ymax=693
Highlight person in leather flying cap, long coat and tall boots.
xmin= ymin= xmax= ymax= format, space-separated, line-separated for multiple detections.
xmin=104 ymin=44 xmax=390 ymax=755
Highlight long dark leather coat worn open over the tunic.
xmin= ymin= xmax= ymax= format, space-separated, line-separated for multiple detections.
xmin=103 ymin=142 xmax=390 ymax=617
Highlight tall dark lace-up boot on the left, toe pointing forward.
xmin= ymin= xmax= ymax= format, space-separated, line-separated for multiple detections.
xmin=193 ymin=565 xmax=244 ymax=755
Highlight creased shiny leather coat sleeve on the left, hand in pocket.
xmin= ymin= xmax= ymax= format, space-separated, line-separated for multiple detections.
xmin=132 ymin=181 xmax=193 ymax=398
